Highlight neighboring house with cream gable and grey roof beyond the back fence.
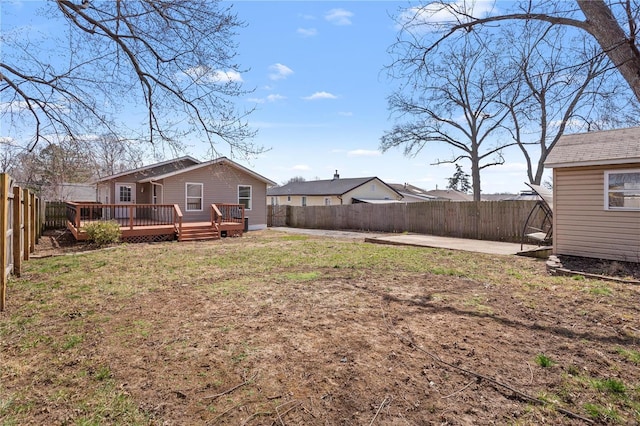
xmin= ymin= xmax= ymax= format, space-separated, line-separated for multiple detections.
xmin=267 ymin=172 xmax=402 ymax=206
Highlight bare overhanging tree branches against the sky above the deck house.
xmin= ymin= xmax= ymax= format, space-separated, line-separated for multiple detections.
xmin=0 ymin=0 xmax=262 ymax=156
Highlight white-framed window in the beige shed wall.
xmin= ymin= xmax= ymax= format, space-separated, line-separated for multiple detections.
xmin=604 ymin=169 xmax=640 ymax=210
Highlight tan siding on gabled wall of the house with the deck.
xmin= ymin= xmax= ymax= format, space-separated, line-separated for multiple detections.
xmin=159 ymin=164 xmax=267 ymax=229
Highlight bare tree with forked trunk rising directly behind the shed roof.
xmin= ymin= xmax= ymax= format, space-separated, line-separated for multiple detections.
xmin=498 ymin=21 xmax=626 ymax=185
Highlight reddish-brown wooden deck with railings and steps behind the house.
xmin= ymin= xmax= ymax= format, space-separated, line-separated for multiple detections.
xmin=67 ymin=203 xmax=244 ymax=242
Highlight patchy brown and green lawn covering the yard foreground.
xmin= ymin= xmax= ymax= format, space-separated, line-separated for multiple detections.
xmin=0 ymin=230 xmax=640 ymax=425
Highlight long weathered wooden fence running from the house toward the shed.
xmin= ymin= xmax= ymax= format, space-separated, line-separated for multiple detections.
xmin=267 ymin=200 xmax=536 ymax=243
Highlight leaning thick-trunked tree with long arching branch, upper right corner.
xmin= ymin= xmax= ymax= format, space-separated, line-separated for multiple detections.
xmin=415 ymin=0 xmax=640 ymax=101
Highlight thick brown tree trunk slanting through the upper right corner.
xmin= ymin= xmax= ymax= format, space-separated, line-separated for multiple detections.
xmin=576 ymin=0 xmax=640 ymax=101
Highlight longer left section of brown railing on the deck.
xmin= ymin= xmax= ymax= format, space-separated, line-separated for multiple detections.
xmin=67 ymin=202 xmax=182 ymax=229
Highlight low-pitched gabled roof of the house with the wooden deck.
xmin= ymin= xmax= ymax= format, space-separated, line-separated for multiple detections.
xmin=97 ymin=156 xmax=276 ymax=185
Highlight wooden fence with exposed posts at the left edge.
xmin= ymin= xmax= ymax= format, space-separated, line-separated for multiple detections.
xmin=0 ymin=173 xmax=42 ymax=311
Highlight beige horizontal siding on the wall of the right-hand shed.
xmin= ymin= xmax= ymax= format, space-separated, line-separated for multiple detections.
xmin=553 ymin=164 xmax=640 ymax=262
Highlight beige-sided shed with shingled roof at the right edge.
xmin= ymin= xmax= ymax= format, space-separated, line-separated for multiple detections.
xmin=545 ymin=127 xmax=640 ymax=262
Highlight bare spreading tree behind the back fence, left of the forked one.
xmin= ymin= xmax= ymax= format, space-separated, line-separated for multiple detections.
xmin=380 ymin=34 xmax=514 ymax=201
